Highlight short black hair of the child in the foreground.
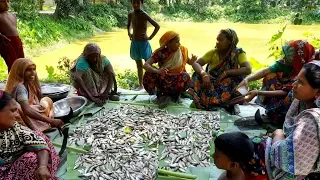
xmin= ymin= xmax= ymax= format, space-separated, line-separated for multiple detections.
xmin=214 ymin=132 xmax=254 ymax=165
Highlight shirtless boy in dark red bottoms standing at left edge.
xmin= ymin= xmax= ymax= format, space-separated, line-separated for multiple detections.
xmin=0 ymin=0 xmax=24 ymax=72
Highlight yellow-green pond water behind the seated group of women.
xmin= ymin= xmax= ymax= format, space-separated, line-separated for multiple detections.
xmin=4 ymin=22 xmax=320 ymax=78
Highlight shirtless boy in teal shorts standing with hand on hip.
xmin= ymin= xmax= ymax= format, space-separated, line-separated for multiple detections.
xmin=127 ymin=0 xmax=160 ymax=90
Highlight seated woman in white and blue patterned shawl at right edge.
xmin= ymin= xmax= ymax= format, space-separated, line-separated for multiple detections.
xmin=245 ymin=61 xmax=320 ymax=180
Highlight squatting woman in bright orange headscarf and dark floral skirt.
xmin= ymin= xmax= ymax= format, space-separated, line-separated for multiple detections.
xmin=143 ymin=31 xmax=197 ymax=108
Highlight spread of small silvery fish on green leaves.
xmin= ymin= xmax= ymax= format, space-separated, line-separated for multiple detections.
xmin=69 ymin=105 xmax=220 ymax=180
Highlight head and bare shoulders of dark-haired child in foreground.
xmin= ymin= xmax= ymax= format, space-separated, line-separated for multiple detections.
xmin=213 ymin=132 xmax=254 ymax=180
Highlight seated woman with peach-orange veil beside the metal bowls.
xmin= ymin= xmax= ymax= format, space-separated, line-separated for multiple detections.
xmin=5 ymin=58 xmax=64 ymax=132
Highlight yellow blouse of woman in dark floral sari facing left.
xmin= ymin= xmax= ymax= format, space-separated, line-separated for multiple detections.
xmin=202 ymin=49 xmax=248 ymax=69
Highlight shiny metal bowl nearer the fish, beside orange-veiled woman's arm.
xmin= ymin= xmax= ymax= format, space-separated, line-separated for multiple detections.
xmin=53 ymin=96 xmax=88 ymax=118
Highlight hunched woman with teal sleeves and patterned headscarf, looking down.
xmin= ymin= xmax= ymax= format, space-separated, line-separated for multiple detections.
xmin=71 ymin=43 xmax=119 ymax=106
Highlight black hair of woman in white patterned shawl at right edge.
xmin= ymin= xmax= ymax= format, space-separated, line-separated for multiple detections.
xmin=303 ymin=63 xmax=320 ymax=89
